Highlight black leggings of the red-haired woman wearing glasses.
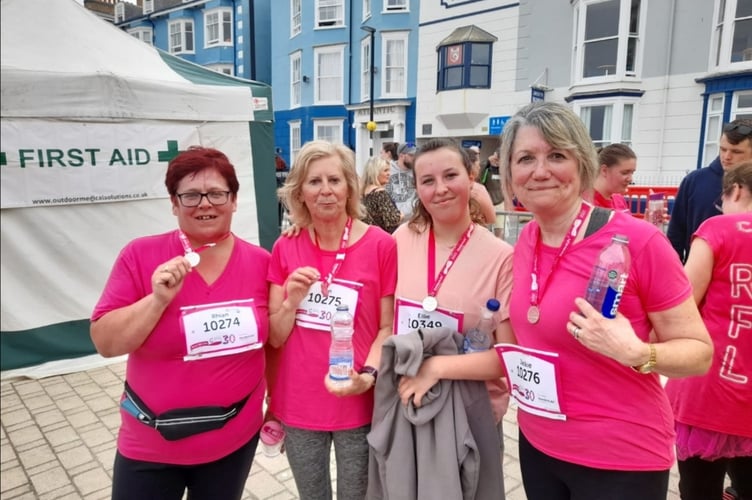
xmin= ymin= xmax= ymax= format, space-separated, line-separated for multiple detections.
xmin=112 ymin=433 xmax=259 ymax=500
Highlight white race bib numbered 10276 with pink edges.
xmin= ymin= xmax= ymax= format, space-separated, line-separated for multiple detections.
xmin=494 ymin=344 xmax=567 ymax=420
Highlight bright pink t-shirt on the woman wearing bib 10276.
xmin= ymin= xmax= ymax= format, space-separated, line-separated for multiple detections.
xmin=511 ymin=212 xmax=691 ymax=470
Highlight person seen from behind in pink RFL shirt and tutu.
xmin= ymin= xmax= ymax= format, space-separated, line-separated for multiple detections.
xmin=666 ymin=161 xmax=752 ymax=500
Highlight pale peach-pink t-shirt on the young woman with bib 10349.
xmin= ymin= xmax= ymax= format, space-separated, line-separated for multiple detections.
xmin=394 ymin=224 xmax=512 ymax=422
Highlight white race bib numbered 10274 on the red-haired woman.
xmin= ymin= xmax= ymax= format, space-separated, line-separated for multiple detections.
xmin=180 ymin=299 xmax=262 ymax=361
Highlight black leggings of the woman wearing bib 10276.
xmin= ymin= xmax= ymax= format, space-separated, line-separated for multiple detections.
xmin=519 ymin=431 xmax=669 ymax=500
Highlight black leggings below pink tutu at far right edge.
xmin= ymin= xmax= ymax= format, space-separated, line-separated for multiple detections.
xmin=679 ymin=457 xmax=752 ymax=500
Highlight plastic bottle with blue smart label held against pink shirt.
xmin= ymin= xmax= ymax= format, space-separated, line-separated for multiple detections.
xmin=585 ymin=234 xmax=630 ymax=318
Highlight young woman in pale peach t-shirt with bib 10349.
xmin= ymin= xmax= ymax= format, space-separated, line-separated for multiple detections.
xmin=394 ymin=139 xmax=512 ymax=498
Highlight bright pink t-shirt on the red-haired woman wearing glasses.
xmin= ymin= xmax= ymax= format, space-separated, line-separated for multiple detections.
xmin=91 ymin=231 xmax=269 ymax=465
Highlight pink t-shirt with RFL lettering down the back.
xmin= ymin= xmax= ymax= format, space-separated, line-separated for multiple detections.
xmin=666 ymin=213 xmax=752 ymax=438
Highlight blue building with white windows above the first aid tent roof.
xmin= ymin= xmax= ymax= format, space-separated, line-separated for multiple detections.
xmin=114 ymin=0 xmax=271 ymax=83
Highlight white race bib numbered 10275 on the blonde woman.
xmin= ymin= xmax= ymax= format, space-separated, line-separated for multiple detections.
xmin=295 ymin=278 xmax=363 ymax=332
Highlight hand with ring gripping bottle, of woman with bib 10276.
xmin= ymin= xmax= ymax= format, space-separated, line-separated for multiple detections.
xmin=567 ymin=298 xmax=648 ymax=366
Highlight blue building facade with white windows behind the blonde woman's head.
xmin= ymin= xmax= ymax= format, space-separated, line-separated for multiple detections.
xmin=271 ymin=0 xmax=419 ymax=170
